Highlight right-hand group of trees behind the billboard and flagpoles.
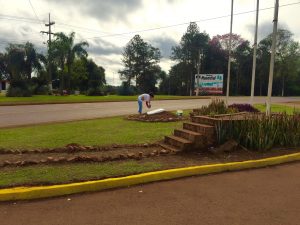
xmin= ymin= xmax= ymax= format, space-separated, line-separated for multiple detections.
xmin=119 ymin=23 xmax=300 ymax=96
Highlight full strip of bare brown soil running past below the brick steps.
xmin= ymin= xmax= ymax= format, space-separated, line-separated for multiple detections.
xmin=0 ymin=144 xmax=299 ymax=168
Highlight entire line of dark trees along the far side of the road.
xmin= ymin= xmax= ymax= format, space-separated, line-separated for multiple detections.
xmin=0 ymin=22 xmax=300 ymax=96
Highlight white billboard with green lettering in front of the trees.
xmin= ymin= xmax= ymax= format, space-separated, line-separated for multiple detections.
xmin=195 ymin=74 xmax=223 ymax=94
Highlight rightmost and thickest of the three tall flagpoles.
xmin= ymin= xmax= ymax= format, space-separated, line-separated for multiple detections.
xmin=266 ymin=0 xmax=279 ymax=115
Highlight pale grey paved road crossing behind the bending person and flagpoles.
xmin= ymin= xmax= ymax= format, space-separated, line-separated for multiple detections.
xmin=0 ymin=97 xmax=300 ymax=128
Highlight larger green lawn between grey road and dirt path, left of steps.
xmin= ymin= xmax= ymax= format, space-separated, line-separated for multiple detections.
xmin=0 ymin=117 xmax=182 ymax=149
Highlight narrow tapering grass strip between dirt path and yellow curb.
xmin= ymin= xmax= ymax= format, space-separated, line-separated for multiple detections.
xmin=0 ymin=161 xmax=162 ymax=188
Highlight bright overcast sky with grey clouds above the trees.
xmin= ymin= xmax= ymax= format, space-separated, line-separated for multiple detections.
xmin=0 ymin=0 xmax=300 ymax=85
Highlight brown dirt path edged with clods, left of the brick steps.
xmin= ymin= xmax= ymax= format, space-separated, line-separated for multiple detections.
xmin=0 ymin=144 xmax=176 ymax=167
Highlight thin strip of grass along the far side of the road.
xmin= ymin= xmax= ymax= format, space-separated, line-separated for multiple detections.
xmin=0 ymin=95 xmax=208 ymax=105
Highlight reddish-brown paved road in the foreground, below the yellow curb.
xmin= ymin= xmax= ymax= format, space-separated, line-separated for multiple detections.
xmin=0 ymin=163 xmax=300 ymax=225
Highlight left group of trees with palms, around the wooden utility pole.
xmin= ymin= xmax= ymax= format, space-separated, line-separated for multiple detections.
xmin=0 ymin=32 xmax=106 ymax=96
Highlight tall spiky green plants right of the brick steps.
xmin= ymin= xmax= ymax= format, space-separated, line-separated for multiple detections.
xmin=216 ymin=114 xmax=300 ymax=150
